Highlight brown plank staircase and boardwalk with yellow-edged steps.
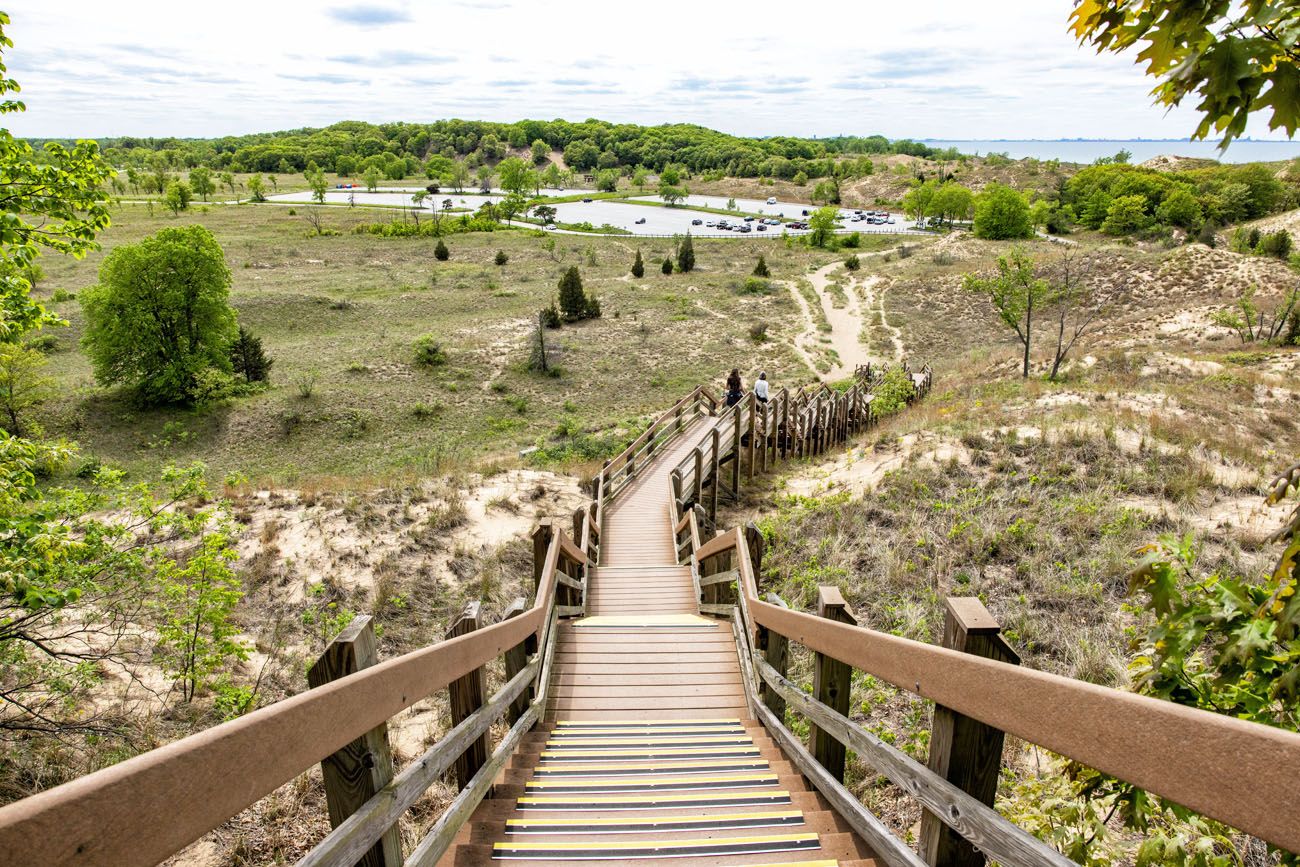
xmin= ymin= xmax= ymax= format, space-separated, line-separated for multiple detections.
xmin=439 ymin=417 xmax=876 ymax=867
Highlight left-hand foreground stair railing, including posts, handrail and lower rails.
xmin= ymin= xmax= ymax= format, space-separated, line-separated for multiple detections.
xmin=0 ymin=522 xmax=599 ymax=867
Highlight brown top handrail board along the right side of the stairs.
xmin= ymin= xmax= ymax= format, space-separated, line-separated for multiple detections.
xmin=697 ymin=529 xmax=1300 ymax=851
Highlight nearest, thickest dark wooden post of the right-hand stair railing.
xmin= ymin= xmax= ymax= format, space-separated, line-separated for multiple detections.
xmin=920 ymin=597 xmax=1021 ymax=867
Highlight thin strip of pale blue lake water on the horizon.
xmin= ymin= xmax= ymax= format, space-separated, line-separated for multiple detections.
xmin=919 ymin=139 xmax=1300 ymax=164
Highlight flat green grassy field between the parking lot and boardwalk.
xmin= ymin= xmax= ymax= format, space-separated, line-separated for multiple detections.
xmin=39 ymin=205 xmax=852 ymax=485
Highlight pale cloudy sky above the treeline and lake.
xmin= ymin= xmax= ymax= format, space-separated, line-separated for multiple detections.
xmin=4 ymin=0 xmax=1281 ymax=139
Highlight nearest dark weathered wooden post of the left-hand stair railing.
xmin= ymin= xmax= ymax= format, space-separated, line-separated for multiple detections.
xmin=307 ymin=615 xmax=402 ymax=867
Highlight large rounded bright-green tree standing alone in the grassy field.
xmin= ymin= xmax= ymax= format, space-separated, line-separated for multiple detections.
xmin=79 ymin=226 xmax=237 ymax=404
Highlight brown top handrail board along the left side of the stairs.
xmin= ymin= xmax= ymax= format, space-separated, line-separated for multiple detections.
xmin=0 ymin=522 xmax=588 ymax=867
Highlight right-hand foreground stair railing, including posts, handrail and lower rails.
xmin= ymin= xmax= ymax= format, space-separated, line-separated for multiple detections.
xmin=694 ymin=529 xmax=1300 ymax=867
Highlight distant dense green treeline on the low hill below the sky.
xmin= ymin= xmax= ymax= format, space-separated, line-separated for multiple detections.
xmin=30 ymin=120 xmax=959 ymax=178
